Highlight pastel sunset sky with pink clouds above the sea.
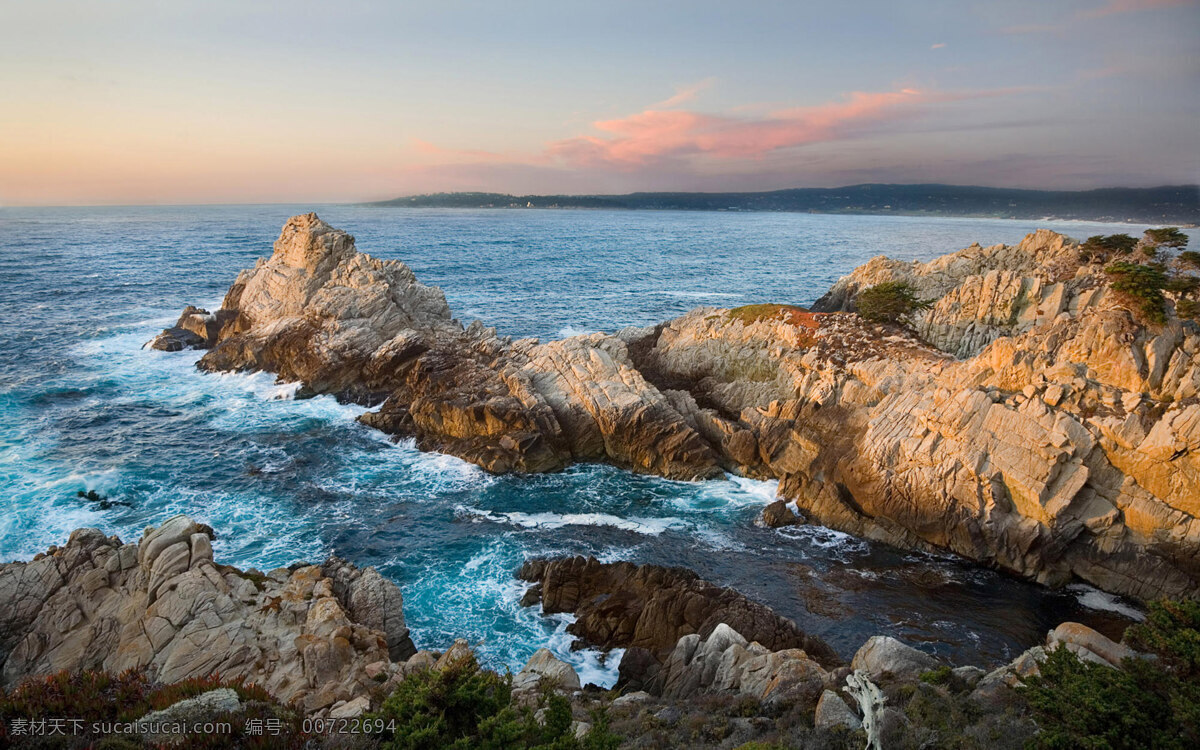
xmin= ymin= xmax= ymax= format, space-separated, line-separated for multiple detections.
xmin=0 ymin=0 xmax=1200 ymax=205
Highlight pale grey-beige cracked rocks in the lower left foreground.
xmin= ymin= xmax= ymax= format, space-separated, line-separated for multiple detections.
xmin=0 ymin=516 xmax=414 ymax=713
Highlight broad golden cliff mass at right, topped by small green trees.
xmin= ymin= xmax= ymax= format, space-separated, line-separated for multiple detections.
xmin=631 ymin=232 xmax=1200 ymax=599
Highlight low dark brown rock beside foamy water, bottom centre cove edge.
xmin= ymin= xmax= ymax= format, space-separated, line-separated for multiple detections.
xmin=517 ymin=557 xmax=841 ymax=679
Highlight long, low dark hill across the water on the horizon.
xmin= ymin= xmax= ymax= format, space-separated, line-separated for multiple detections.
xmin=368 ymin=185 xmax=1200 ymax=224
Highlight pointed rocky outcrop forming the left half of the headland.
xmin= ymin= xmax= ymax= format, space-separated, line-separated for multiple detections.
xmin=152 ymin=214 xmax=720 ymax=479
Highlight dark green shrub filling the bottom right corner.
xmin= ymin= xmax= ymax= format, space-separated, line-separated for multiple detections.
xmin=1018 ymin=601 xmax=1200 ymax=750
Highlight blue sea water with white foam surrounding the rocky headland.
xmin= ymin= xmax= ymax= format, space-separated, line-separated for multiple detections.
xmin=0 ymin=205 xmax=1161 ymax=684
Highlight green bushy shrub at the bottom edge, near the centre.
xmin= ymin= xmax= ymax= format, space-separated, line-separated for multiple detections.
xmin=371 ymin=655 xmax=620 ymax=750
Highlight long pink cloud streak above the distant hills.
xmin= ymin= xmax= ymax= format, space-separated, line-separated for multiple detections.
xmin=546 ymin=89 xmax=936 ymax=168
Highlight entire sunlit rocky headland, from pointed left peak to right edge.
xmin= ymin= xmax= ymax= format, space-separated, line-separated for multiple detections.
xmin=152 ymin=215 xmax=1200 ymax=598
